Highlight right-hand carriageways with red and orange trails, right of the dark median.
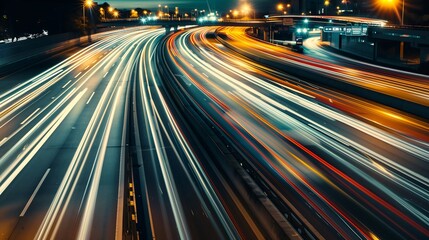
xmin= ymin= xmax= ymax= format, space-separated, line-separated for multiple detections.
xmin=163 ymin=28 xmax=429 ymax=239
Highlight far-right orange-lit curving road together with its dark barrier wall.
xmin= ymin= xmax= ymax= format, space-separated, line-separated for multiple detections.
xmin=218 ymin=28 xmax=429 ymax=118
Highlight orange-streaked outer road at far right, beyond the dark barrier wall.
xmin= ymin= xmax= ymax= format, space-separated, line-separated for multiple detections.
xmin=222 ymin=28 xmax=429 ymax=112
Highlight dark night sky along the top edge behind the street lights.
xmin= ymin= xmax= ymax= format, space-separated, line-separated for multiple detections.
xmin=0 ymin=0 xmax=429 ymax=33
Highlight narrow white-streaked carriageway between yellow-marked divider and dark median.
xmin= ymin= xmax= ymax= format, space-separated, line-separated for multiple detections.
xmin=133 ymin=27 xmax=238 ymax=239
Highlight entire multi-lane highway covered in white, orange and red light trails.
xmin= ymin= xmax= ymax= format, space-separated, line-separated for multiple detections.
xmin=0 ymin=23 xmax=429 ymax=239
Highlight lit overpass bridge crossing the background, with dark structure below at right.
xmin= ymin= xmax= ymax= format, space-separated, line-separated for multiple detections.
xmin=101 ymin=15 xmax=429 ymax=72
